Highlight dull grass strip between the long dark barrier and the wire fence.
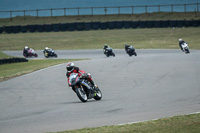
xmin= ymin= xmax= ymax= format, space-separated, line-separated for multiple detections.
xmin=0 ymin=12 xmax=200 ymax=26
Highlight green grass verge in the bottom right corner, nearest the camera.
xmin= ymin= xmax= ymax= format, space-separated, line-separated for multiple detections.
xmin=48 ymin=114 xmax=200 ymax=133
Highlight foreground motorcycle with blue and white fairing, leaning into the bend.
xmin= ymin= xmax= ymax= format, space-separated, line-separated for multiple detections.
xmin=69 ymin=73 xmax=102 ymax=102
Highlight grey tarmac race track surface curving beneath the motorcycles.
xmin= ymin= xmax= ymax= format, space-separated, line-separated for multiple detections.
xmin=0 ymin=49 xmax=200 ymax=133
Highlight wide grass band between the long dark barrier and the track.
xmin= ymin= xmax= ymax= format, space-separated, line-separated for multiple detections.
xmin=0 ymin=27 xmax=200 ymax=51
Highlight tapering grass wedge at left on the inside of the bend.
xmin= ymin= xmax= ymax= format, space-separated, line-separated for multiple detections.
xmin=0 ymin=59 xmax=82 ymax=81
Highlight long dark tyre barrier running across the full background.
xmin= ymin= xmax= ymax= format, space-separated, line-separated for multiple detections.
xmin=0 ymin=20 xmax=200 ymax=33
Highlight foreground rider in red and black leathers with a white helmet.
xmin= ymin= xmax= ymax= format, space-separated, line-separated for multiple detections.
xmin=66 ymin=62 xmax=97 ymax=91
